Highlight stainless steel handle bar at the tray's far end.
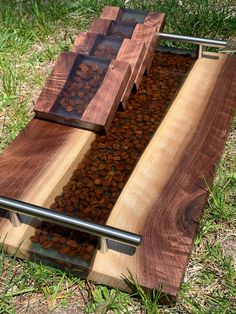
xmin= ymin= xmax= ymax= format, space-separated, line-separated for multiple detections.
xmin=159 ymin=33 xmax=227 ymax=48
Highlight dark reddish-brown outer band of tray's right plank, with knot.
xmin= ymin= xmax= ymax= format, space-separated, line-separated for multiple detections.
xmin=138 ymin=57 xmax=236 ymax=295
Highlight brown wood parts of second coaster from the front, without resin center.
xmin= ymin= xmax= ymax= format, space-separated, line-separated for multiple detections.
xmin=72 ymin=32 xmax=146 ymax=108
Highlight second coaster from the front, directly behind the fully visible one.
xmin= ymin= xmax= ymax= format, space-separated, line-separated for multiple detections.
xmin=72 ymin=32 xmax=146 ymax=108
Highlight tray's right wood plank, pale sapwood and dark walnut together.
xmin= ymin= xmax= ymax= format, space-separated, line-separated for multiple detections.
xmin=89 ymin=56 xmax=236 ymax=298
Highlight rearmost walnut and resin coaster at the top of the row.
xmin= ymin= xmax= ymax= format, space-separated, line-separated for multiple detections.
xmin=101 ymin=6 xmax=165 ymax=31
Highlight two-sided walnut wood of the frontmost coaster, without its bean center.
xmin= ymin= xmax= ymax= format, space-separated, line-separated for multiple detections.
xmin=34 ymin=52 xmax=131 ymax=132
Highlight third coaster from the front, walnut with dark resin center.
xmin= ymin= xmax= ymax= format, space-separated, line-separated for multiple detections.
xmin=89 ymin=17 xmax=164 ymax=87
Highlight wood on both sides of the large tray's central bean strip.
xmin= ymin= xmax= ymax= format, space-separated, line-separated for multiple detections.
xmin=0 ymin=55 xmax=236 ymax=297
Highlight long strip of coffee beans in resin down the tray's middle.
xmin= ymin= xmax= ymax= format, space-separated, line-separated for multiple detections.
xmin=31 ymin=52 xmax=194 ymax=265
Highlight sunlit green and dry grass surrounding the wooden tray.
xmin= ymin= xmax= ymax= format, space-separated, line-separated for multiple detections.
xmin=0 ymin=0 xmax=236 ymax=314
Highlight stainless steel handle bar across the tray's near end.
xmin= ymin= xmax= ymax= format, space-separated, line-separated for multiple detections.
xmin=0 ymin=196 xmax=142 ymax=247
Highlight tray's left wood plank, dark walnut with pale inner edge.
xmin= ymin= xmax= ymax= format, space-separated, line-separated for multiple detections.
xmin=0 ymin=119 xmax=95 ymax=258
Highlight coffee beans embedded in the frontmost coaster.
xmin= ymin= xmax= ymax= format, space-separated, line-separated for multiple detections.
xmin=56 ymin=63 xmax=106 ymax=115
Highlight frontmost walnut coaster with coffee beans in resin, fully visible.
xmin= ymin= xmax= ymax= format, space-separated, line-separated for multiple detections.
xmin=34 ymin=52 xmax=131 ymax=132
